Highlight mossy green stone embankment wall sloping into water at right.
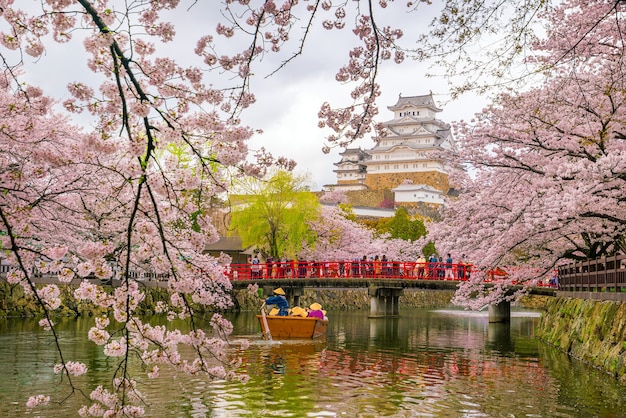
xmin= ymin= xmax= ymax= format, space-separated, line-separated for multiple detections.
xmin=536 ymin=298 xmax=626 ymax=384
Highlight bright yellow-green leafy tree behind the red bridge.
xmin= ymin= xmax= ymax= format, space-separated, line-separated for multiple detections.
xmin=230 ymin=171 xmax=321 ymax=259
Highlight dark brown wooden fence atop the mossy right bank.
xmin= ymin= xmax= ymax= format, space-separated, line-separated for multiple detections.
xmin=559 ymin=254 xmax=626 ymax=292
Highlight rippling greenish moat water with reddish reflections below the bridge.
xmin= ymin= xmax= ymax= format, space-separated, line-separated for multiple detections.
xmin=0 ymin=309 xmax=626 ymax=417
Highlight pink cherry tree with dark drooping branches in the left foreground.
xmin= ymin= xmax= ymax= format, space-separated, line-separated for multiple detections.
xmin=0 ymin=0 xmax=414 ymax=416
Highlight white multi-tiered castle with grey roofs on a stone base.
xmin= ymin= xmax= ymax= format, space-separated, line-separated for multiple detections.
xmin=329 ymin=94 xmax=456 ymax=206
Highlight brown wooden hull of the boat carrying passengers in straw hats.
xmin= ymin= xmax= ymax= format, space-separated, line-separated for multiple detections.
xmin=256 ymin=314 xmax=328 ymax=339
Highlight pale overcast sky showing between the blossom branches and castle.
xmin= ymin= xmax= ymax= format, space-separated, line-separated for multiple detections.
xmin=12 ymin=0 xmax=486 ymax=190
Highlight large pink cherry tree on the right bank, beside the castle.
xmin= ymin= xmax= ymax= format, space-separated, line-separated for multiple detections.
xmin=429 ymin=0 xmax=626 ymax=306
